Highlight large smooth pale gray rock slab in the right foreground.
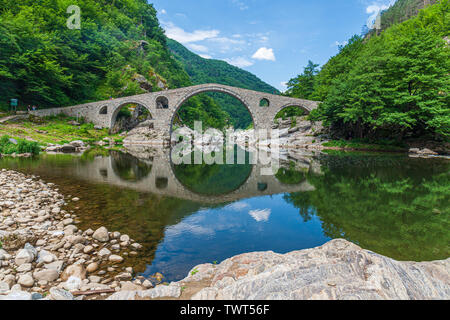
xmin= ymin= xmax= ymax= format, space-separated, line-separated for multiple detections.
xmin=180 ymin=239 xmax=450 ymax=300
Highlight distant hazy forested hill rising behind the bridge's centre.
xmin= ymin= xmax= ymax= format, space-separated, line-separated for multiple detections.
xmin=167 ymin=39 xmax=280 ymax=128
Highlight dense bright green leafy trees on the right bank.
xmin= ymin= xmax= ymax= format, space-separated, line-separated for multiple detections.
xmin=290 ymin=0 xmax=450 ymax=141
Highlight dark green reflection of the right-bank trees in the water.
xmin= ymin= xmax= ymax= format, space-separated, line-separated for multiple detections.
xmin=285 ymin=155 xmax=450 ymax=261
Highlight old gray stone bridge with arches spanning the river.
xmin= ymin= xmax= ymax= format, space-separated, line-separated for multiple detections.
xmin=31 ymin=84 xmax=318 ymax=136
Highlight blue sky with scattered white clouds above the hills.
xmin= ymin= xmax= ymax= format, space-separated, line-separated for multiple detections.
xmin=149 ymin=0 xmax=394 ymax=91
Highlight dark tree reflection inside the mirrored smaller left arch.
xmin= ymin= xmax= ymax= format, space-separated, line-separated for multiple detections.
xmin=110 ymin=151 xmax=152 ymax=182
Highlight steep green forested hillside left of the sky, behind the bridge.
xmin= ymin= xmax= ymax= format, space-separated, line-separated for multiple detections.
xmin=0 ymin=0 xmax=237 ymax=128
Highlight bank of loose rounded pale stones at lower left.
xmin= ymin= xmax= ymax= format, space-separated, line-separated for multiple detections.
xmin=0 ymin=169 xmax=158 ymax=300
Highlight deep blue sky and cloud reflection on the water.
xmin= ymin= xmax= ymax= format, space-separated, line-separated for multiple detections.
xmin=145 ymin=195 xmax=330 ymax=281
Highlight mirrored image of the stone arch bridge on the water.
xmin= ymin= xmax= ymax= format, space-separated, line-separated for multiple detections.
xmin=68 ymin=147 xmax=317 ymax=204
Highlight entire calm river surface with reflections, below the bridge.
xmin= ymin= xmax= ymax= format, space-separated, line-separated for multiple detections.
xmin=0 ymin=146 xmax=450 ymax=281
